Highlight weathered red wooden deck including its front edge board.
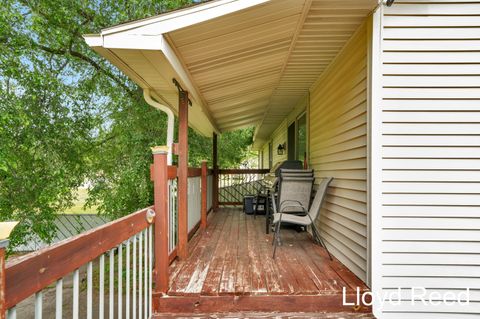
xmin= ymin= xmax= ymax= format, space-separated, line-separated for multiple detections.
xmin=155 ymin=208 xmax=370 ymax=313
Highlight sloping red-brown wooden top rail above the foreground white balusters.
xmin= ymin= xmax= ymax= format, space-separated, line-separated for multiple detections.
xmin=5 ymin=207 xmax=152 ymax=309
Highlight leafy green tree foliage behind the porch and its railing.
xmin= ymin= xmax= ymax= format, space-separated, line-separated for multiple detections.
xmin=0 ymin=0 xmax=252 ymax=250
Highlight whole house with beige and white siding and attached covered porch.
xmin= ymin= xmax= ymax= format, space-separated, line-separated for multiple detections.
xmin=1 ymin=0 xmax=480 ymax=319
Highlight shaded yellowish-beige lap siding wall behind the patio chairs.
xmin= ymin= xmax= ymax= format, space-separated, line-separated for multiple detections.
xmin=309 ymin=21 xmax=367 ymax=281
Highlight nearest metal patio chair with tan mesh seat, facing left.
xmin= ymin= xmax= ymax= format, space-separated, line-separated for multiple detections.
xmin=273 ymin=177 xmax=333 ymax=260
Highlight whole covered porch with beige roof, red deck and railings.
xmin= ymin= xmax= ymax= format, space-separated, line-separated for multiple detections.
xmin=4 ymin=0 xmax=378 ymax=318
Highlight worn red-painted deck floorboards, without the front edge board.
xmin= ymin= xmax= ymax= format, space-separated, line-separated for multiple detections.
xmin=168 ymin=208 xmax=367 ymax=296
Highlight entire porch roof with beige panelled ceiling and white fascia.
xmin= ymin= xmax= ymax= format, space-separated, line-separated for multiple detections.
xmin=85 ymin=0 xmax=378 ymax=142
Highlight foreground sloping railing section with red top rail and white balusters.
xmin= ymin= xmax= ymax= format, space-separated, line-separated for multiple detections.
xmin=2 ymin=208 xmax=157 ymax=318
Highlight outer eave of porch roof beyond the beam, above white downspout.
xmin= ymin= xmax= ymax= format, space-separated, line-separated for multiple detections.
xmin=84 ymin=34 xmax=219 ymax=136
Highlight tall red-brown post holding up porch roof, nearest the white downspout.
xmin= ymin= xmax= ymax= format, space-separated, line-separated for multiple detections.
xmin=177 ymin=90 xmax=188 ymax=259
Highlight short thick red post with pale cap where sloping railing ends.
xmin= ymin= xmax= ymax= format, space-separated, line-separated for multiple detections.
xmin=152 ymin=147 xmax=169 ymax=293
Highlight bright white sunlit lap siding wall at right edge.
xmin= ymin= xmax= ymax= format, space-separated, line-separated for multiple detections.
xmin=380 ymin=0 xmax=480 ymax=318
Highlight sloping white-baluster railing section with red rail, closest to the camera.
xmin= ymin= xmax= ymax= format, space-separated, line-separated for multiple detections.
xmin=6 ymin=210 xmax=154 ymax=319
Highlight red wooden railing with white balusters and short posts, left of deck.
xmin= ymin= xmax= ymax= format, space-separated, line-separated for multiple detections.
xmin=0 ymin=149 xmax=213 ymax=319
